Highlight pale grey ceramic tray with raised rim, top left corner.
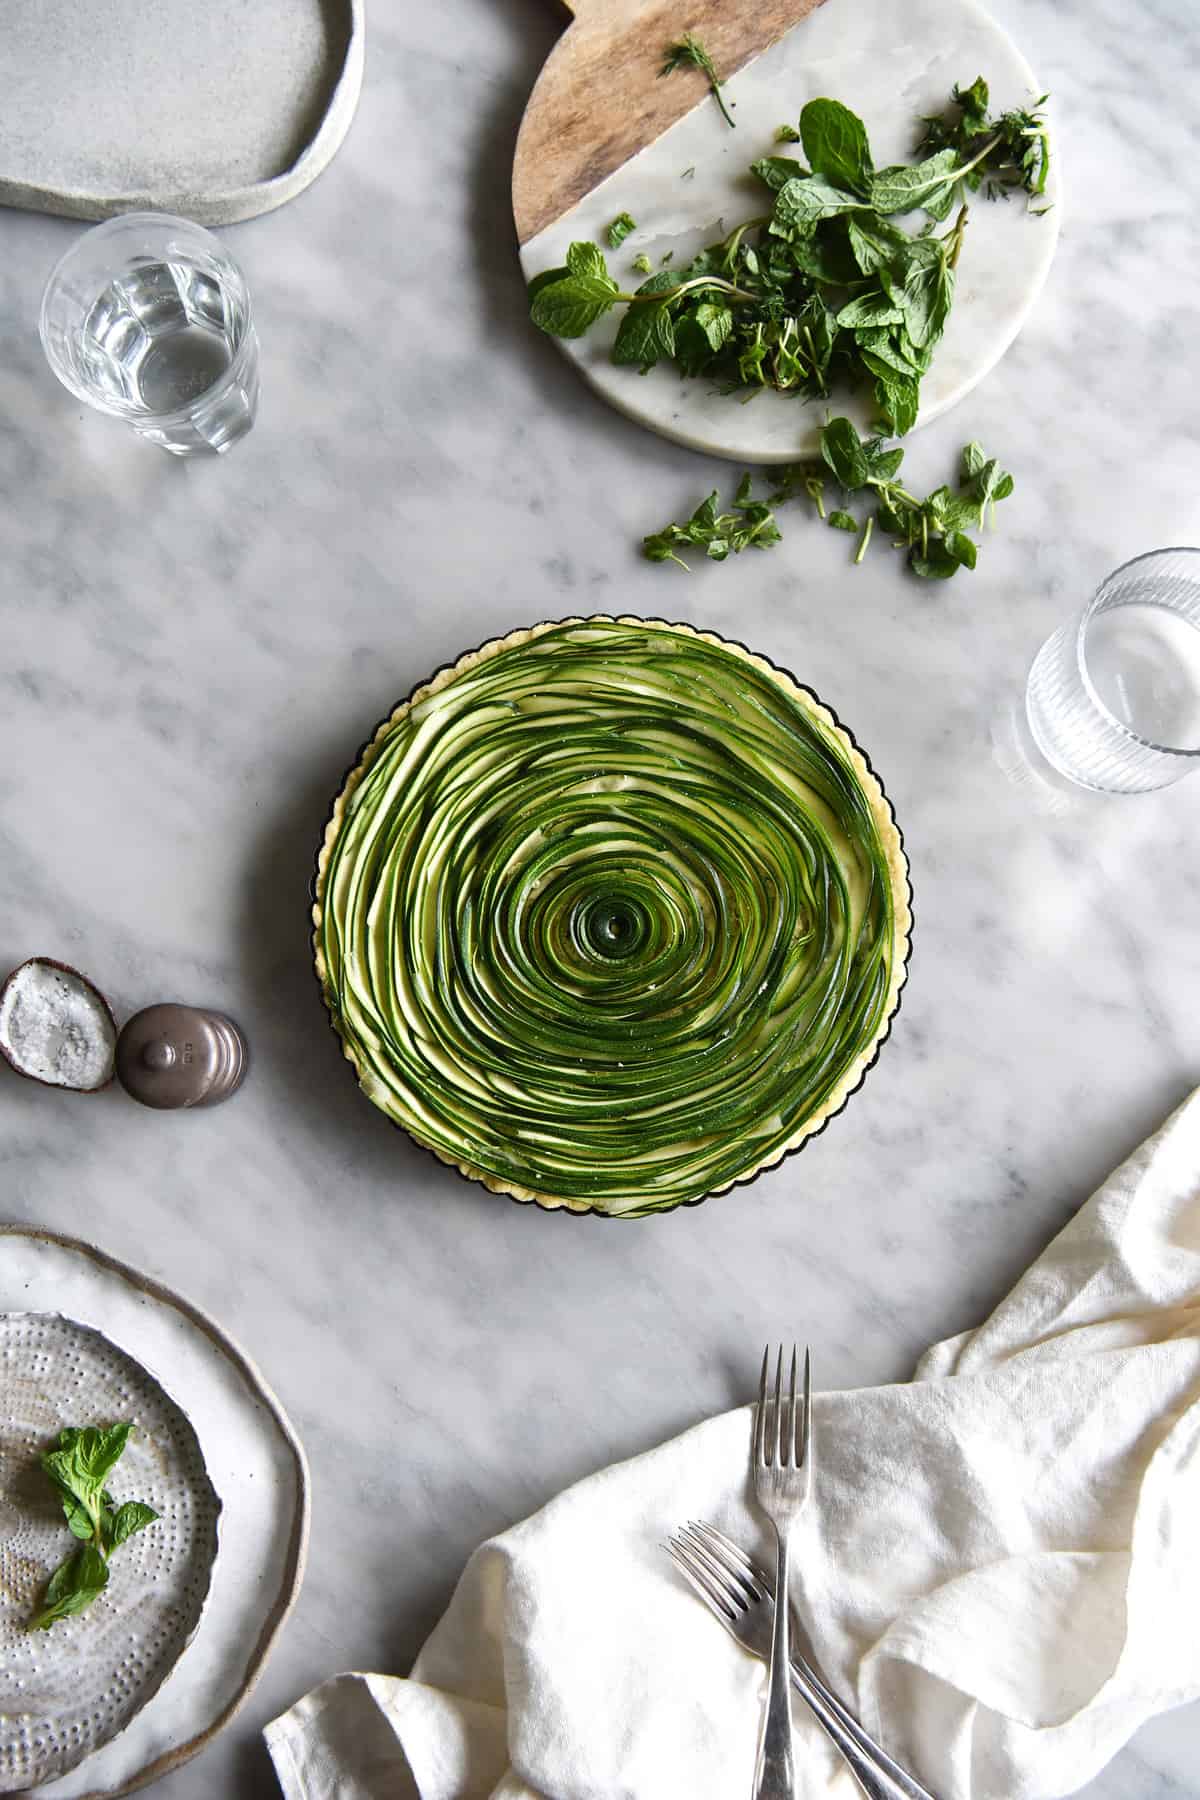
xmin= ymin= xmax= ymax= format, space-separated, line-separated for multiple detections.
xmin=0 ymin=0 xmax=363 ymax=225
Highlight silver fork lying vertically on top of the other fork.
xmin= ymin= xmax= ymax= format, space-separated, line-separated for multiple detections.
xmin=750 ymin=1345 xmax=813 ymax=1800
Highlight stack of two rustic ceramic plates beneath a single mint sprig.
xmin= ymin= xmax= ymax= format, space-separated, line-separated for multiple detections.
xmin=0 ymin=1224 xmax=309 ymax=1800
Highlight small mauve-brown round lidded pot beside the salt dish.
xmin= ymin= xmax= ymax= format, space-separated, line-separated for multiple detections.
xmin=117 ymin=1001 xmax=246 ymax=1109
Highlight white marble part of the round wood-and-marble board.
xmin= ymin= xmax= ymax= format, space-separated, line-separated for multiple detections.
xmin=520 ymin=0 xmax=1060 ymax=463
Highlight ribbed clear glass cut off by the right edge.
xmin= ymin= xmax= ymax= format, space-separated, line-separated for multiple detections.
xmin=1025 ymin=549 xmax=1200 ymax=794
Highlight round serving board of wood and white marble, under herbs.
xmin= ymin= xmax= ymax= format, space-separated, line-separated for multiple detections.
xmin=513 ymin=0 xmax=1060 ymax=464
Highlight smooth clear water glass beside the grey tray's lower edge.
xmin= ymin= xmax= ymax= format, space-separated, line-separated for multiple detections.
xmin=40 ymin=212 xmax=259 ymax=455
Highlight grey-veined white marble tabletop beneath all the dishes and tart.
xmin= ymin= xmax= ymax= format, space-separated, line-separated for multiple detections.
xmin=0 ymin=0 xmax=1200 ymax=1800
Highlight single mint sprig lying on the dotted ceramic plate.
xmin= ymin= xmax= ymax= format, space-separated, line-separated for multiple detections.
xmin=29 ymin=1420 xmax=158 ymax=1631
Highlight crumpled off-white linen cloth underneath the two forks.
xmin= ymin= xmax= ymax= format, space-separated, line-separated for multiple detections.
xmin=266 ymin=1091 xmax=1200 ymax=1800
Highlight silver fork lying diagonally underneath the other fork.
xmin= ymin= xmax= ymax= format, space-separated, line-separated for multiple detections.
xmin=666 ymin=1519 xmax=934 ymax=1800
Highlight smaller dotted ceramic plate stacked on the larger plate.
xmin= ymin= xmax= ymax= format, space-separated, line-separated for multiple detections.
xmin=0 ymin=1312 xmax=221 ymax=1793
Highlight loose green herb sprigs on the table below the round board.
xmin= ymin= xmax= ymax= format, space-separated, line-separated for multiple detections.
xmin=642 ymin=419 xmax=1013 ymax=581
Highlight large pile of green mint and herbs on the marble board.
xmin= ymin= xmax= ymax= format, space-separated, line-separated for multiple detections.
xmin=529 ymin=76 xmax=1049 ymax=437
